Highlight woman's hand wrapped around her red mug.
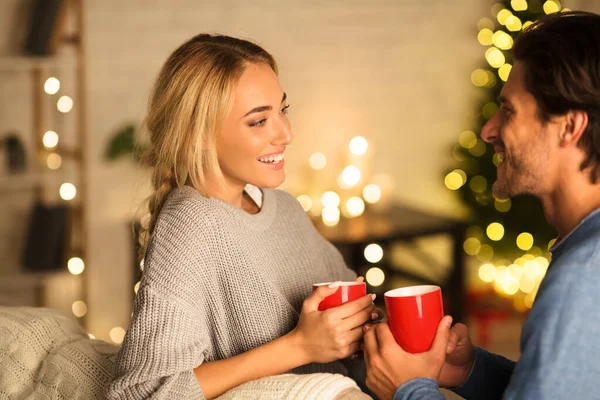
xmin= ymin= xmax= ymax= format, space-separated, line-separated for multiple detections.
xmin=292 ymin=283 xmax=375 ymax=364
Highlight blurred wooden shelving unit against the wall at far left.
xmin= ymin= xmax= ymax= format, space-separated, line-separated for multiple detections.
xmin=0 ymin=0 xmax=88 ymax=326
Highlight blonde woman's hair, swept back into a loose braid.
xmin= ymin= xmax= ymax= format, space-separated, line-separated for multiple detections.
xmin=139 ymin=34 xmax=277 ymax=260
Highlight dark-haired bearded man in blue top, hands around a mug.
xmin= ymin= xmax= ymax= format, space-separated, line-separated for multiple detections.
xmin=364 ymin=12 xmax=600 ymax=400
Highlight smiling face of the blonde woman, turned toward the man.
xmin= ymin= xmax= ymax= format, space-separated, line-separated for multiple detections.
xmin=216 ymin=64 xmax=294 ymax=190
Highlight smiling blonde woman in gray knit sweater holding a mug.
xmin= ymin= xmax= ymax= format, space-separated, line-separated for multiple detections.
xmin=107 ymin=34 xmax=377 ymax=399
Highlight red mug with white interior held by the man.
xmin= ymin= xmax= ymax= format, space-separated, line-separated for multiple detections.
xmin=384 ymin=285 xmax=444 ymax=353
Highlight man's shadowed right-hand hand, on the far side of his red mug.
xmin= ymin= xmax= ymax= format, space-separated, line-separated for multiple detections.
xmin=438 ymin=324 xmax=475 ymax=388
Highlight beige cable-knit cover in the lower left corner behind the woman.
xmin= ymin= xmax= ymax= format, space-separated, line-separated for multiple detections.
xmin=0 ymin=307 xmax=118 ymax=400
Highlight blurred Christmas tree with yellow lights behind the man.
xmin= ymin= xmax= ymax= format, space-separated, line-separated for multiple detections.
xmin=445 ymin=0 xmax=566 ymax=306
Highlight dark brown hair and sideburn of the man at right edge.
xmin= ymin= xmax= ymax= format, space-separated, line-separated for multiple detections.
xmin=514 ymin=11 xmax=600 ymax=182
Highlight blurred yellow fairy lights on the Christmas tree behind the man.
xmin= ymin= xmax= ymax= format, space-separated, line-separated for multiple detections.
xmin=444 ymin=0 xmax=568 ymax=311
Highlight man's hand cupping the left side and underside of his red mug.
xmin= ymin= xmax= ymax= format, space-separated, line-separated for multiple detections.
xmin=363 ymin=316 xmax=452 ymax=400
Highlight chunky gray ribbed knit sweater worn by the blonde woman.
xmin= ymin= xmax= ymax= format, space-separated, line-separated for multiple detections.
xmin=107 ymin=187 xmax=356 ymax=399
